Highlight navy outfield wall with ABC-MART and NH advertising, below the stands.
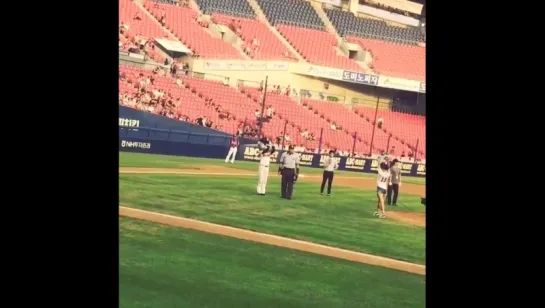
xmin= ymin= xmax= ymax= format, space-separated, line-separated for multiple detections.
xmin=119 ymin=133 xmax=426 ymax=177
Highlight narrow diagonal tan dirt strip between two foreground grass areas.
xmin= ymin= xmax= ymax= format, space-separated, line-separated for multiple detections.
xmin=119 ymin=206 xmax=426 ymax=275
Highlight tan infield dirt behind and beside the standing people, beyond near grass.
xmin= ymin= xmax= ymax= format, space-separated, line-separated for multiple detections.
xmin=119 ymin=165 xmax=426 ymax=227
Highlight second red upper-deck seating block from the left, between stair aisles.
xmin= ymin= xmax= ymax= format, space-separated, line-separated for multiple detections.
xmin=142 ymin=0 xmax=243 ymax=59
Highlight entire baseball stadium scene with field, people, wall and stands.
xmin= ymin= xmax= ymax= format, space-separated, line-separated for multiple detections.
xmin=118 ymin=0 xmax=426 ymax=308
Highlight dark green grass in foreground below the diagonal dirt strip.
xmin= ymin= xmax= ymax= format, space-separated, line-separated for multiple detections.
xmin=119 ymin=218 xmax=425 ymax=308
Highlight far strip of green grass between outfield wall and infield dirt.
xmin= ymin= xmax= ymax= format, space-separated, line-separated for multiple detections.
xmin=119 ymin=152 xmax=426 ymax=184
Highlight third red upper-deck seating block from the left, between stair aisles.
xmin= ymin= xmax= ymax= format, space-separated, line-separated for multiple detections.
xmin=212 ymin=13 xmax=297 ymax=61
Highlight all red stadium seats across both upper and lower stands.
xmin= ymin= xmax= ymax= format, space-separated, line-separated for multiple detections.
xmin=119 ymin=0 xmax=426 ymax=155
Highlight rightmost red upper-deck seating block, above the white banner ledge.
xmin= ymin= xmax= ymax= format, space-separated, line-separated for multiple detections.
xmin=346 ymin=36 xmax=426 ymax=81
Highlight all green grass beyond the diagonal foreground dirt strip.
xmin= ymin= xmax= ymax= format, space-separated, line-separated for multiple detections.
xmin=119 ymin=153 xmax=425 ymax=264
